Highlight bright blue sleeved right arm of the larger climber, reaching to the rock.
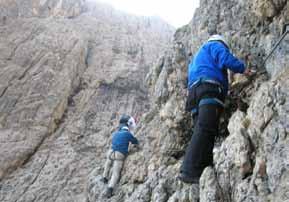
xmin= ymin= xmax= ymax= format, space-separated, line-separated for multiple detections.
xmin=212 ymin=44 xmax=246 ymax=73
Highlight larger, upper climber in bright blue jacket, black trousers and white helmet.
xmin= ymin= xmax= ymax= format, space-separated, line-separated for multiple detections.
xmin=178 ymin=35 xmax=249 ymax=183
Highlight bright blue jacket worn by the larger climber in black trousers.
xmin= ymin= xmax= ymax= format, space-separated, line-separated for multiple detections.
xmin=188 ymin=41 xmax=245 ymax=94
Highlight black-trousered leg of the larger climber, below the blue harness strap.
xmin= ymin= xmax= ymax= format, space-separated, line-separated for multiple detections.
xmin=181 ymin=105 xmax=221 ymax=181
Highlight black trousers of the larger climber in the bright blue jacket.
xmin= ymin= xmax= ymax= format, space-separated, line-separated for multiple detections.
xmin=181 ymin=84 xmax=225 ymax=177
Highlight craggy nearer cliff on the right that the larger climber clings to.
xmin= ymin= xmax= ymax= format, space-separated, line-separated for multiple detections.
xmin=105 ymin=0 xmax=289 ymax=202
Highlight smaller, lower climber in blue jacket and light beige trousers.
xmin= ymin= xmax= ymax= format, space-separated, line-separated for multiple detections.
xmin=102 ymin=115 xmax=139 ymax=198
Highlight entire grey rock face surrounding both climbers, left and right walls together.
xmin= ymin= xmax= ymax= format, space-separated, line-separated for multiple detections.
xmin=0 ymin=0 xmax=289 ymax=202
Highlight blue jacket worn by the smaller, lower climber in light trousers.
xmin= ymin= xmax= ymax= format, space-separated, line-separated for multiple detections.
xmin=112 ymin=127 xmax=138 ymax=155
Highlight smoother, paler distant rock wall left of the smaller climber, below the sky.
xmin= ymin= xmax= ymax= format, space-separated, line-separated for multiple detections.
xmin=0 ymin=1 xmax=174 ymax=202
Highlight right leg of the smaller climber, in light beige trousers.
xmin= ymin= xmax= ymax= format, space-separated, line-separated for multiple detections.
xmin=108 ymin=151 xmax=125 ymax=188
